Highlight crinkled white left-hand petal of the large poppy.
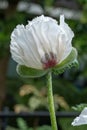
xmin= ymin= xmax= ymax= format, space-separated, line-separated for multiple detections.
xmin=10 ymin=25 xmax=42 ymax=69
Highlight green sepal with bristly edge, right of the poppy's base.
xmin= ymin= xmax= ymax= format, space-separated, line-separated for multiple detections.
xmin=52 ymin=48 xmax=78 ymax=74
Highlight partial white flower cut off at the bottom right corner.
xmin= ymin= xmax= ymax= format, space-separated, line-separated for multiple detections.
xmin=72 ymin=107 xmax=87 ymax=126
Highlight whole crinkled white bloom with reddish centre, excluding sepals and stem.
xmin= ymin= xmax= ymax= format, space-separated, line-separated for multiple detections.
xmin=10 ymin=15 xmax=74 ymax=70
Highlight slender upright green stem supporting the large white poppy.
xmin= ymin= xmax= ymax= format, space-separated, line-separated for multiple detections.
xmin=47 ymin=72 xmax=58 ymax=130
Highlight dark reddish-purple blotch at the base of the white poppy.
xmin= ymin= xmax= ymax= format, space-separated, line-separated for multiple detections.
xmin=41 ymin=52 xmax=57 ymax=69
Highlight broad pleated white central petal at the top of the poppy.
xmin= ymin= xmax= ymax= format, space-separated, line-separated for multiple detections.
xmin=26 ymin=15 xmax=59 ymax=56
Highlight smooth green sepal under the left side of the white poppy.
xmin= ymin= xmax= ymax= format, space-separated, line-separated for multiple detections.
xmin=17 ymin=65 xmax=47 ymax=78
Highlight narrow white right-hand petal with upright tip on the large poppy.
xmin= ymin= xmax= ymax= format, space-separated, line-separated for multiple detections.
xmin=59 ymin=15 xmax=74 ymax=62
